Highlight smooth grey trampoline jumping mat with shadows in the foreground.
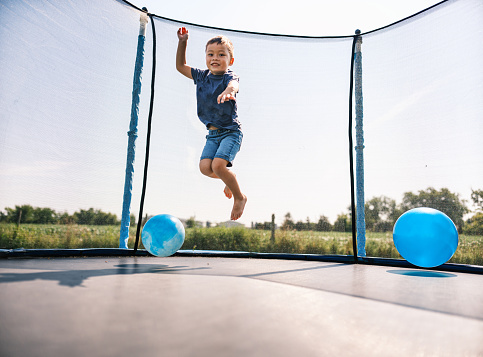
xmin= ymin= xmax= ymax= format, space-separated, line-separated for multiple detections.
xmin=0 ymin=257 xmax=483 ymax=357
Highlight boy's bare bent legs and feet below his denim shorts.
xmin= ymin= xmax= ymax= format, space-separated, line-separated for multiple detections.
xmin=200 ymin=158 xmax=247 ymax=221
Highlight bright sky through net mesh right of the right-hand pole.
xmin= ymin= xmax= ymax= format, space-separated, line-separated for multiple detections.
xmin=362 ymin=1 xmax=483 ymax=228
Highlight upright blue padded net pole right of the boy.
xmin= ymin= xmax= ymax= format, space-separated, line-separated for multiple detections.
xmin=354 ymin=30 xmax=366 ymax=257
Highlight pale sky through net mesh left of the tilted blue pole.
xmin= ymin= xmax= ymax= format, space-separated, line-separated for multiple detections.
xmin=0 ymin=1 xmax=143 ymax=213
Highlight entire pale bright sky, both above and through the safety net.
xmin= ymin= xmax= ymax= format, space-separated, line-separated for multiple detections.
xmin=0 ymin=0 xmax=483 ymax=226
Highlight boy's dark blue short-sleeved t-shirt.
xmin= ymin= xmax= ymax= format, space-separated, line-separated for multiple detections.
xmin=191 ymin=68 xmax=241 ymax=130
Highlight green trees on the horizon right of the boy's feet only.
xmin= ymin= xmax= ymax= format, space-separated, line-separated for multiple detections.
xmin=253 ymin=187 xmax=483 ymax=235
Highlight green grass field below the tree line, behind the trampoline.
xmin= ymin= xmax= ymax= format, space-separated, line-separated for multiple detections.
xmin=0 ymin=224 xmax=483 ymax=265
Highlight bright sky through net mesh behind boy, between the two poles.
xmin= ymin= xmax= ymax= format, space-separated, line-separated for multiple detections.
xmin=145 ymin=20 xmax=352 ymax=228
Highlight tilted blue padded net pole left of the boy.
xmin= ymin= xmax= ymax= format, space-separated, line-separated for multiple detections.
xmin=119 ymin=8 xmax=148 ymax=249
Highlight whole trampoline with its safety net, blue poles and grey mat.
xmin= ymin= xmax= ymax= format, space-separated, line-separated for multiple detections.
xmin=0 ymin=0 xmax=483 ymax=357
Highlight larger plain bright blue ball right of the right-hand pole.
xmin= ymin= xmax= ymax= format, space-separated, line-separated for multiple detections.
xmin=393 ymin=207 xmax=458 ymax=268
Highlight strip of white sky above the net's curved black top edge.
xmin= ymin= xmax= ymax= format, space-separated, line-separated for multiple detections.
xmin=132 ymin=0 xmax=439 ymax=36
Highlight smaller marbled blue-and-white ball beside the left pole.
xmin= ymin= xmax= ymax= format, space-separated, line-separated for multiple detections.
xmin=141 ymin=214 xmax=185 ymax=257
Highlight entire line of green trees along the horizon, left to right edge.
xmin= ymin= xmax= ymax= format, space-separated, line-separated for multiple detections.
xmin=0 ymin=187 xmax=483 ymax=235
